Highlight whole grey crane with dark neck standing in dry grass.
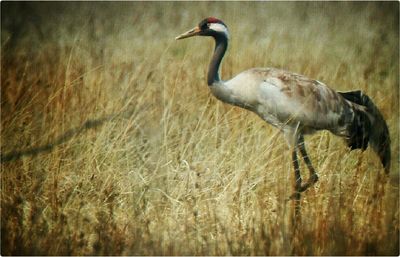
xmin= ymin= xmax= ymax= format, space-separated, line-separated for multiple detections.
xmin=175 ymin=17 xmax=391 ymax=199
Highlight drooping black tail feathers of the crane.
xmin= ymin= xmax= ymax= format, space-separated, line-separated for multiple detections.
xmin=339 ymin=90 xmax=391 ymax=173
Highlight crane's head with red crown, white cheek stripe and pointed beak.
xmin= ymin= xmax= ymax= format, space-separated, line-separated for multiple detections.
xmin=175 ymin=17 xmax=229 ymax=40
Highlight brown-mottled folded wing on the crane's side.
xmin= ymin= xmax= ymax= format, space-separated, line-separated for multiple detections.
xmin=250 ymin=69 xmax=350 ymax=134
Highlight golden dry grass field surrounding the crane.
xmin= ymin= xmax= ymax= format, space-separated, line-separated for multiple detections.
xmin=1 ymin=2 xmax=399 ymax=255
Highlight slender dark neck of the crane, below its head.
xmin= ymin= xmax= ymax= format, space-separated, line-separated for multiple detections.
xmin=207 ymin=35 xmax=228 ymax=86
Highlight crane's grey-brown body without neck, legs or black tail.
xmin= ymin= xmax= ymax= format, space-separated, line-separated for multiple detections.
xmin=210 ymin=68 xmax=355 ymax=140
